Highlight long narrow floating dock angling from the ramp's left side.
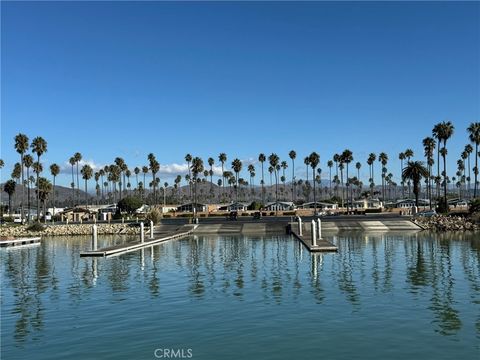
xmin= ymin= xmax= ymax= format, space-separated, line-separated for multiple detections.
xmin=80 ymin=225 xmax=195 ymax=257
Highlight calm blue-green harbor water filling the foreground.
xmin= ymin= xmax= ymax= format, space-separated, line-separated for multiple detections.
xmin=1 ymin=233 xmax=480 ymax=360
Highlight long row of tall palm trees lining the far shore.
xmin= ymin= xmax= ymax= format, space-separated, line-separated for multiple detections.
xmin=2 ymin=121 xmax=480 ymax=221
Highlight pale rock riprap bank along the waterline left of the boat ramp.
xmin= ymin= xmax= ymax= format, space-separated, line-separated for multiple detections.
xmin=0 ymin=224 xmax=140 ymax=237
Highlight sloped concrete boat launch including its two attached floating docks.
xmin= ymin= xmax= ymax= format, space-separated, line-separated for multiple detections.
xmin=80 ymin=219 xmax=422 ymax=257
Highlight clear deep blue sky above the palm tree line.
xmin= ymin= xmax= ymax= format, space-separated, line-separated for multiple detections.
xmin=1 ymin=2 xmax=480 ymax=188
